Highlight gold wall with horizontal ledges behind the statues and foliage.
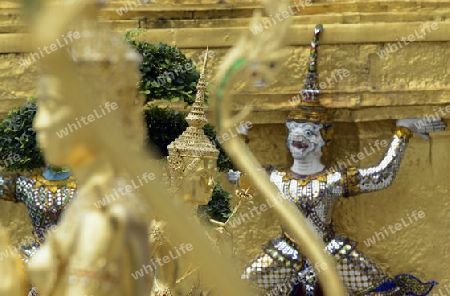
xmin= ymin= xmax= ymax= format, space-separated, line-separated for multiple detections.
xmin=0 ymin=0 xmax=450 ymax=293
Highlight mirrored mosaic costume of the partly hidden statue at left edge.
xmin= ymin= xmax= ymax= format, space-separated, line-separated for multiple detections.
xmin=0 ymin=173 xmax=76 ymax=263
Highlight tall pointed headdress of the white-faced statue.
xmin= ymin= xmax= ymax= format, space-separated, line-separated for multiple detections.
xmin=287 ymin=25 xmax=330 ymax=123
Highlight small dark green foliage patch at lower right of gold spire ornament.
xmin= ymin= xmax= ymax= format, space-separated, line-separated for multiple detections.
xmin=198 ymin=182 xmax=232 ymax=222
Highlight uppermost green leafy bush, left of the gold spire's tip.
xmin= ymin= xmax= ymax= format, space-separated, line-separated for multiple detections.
xmin=125 ymin=29 xmax=200 ymax=105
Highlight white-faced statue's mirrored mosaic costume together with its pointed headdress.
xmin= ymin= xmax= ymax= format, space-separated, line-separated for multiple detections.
xmin=242 ymin=25 xmax=436 ymax=296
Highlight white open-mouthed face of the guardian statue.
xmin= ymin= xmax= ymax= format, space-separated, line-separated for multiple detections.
xmin=286 ymin=122 xmax=325 ymax=159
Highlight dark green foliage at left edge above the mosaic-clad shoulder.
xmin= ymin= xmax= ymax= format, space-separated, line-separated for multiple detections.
xmin=0 ymin=97 xmax=45 ymax=171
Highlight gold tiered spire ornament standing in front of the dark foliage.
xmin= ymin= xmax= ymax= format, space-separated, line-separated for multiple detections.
xmin=167 ymin=49 xmax=219 ymax=206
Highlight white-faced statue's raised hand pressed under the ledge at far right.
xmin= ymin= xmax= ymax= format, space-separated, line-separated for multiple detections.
xmin=397 ymin=118 xmax=446 ymax=140
